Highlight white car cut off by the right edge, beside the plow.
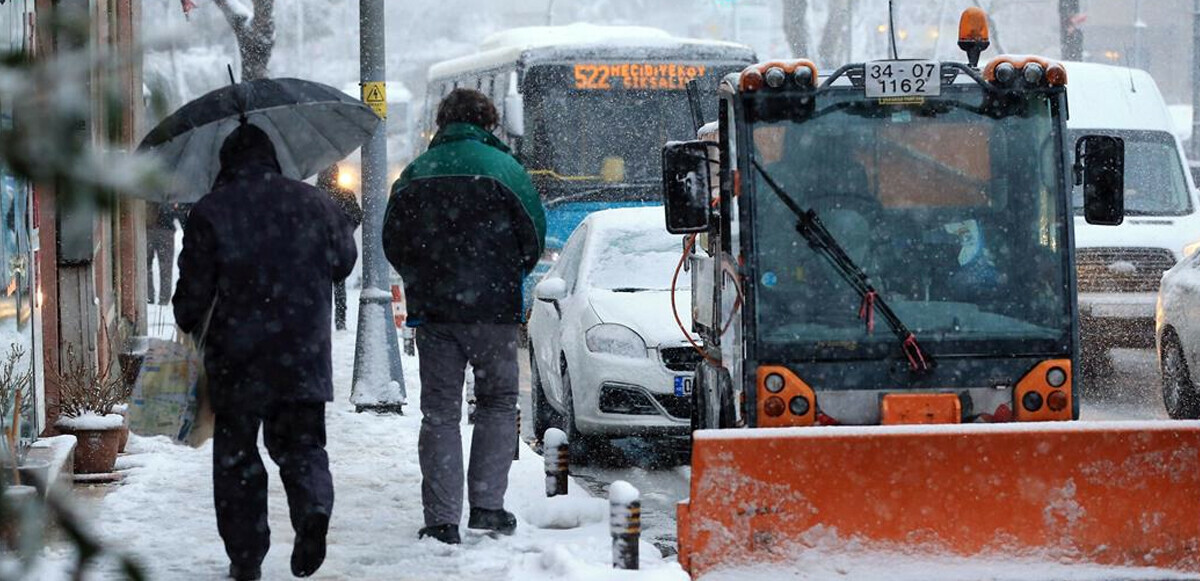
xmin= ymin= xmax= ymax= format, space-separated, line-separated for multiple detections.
xmin=1154 ymin=252 xmax=1200 ymax=419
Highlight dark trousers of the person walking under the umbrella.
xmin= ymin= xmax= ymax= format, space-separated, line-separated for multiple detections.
xmin=212 ymin=402 xmax=334 ymax=567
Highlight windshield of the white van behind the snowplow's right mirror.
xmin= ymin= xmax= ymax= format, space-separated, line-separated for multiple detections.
xmin=1072 ymin=130 xmax=1192 ymax=216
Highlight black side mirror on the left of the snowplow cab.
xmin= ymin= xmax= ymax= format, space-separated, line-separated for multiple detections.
xmin=662 ymin=142 xmax=712 ymax=234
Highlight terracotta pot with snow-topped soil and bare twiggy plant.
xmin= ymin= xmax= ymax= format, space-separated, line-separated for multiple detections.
xmin=48 ymin=347 xmax=130 ymax=474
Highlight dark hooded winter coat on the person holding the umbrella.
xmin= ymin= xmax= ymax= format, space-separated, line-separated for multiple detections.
xmin=174 ymin=125 xmax=356 ymax=412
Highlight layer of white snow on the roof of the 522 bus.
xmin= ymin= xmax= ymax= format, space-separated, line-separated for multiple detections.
xmin=428 ymin=23 xmax=751 ymax=80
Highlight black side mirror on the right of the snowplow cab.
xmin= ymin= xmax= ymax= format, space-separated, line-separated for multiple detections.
xmin=1075 ymin=136 xmax=1124 ymax=226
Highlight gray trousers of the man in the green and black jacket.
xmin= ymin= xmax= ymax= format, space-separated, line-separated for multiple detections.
xmin=416 ymin=323 xmax=518 ymax=526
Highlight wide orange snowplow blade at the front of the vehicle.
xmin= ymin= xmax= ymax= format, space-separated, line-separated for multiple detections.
xmin=678 ymin=421 xmax=1200 ymax=576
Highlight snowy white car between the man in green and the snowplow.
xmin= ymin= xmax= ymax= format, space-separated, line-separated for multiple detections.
xmin=529 ymin=206 xmax=701 ymax=456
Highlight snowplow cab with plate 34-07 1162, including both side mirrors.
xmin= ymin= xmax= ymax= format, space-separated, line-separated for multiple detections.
xmin=664 ymin=56 xmax=1123 ymax=429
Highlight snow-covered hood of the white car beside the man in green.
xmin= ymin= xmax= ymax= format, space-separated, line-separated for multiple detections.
xmin=588 ymin=288 xmax=691 ymax=347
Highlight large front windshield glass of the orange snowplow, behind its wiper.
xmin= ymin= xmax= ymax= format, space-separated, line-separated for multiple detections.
xmin=751 ymin=90 xmax=1070 ymax=358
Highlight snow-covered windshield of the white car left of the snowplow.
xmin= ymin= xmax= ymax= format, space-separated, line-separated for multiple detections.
xmin=588 ymin=224 xmax=691 ymax=292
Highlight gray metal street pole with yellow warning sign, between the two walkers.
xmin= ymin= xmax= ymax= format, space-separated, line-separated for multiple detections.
xmin=350 ymin=0 xmax=406 ymax=413
